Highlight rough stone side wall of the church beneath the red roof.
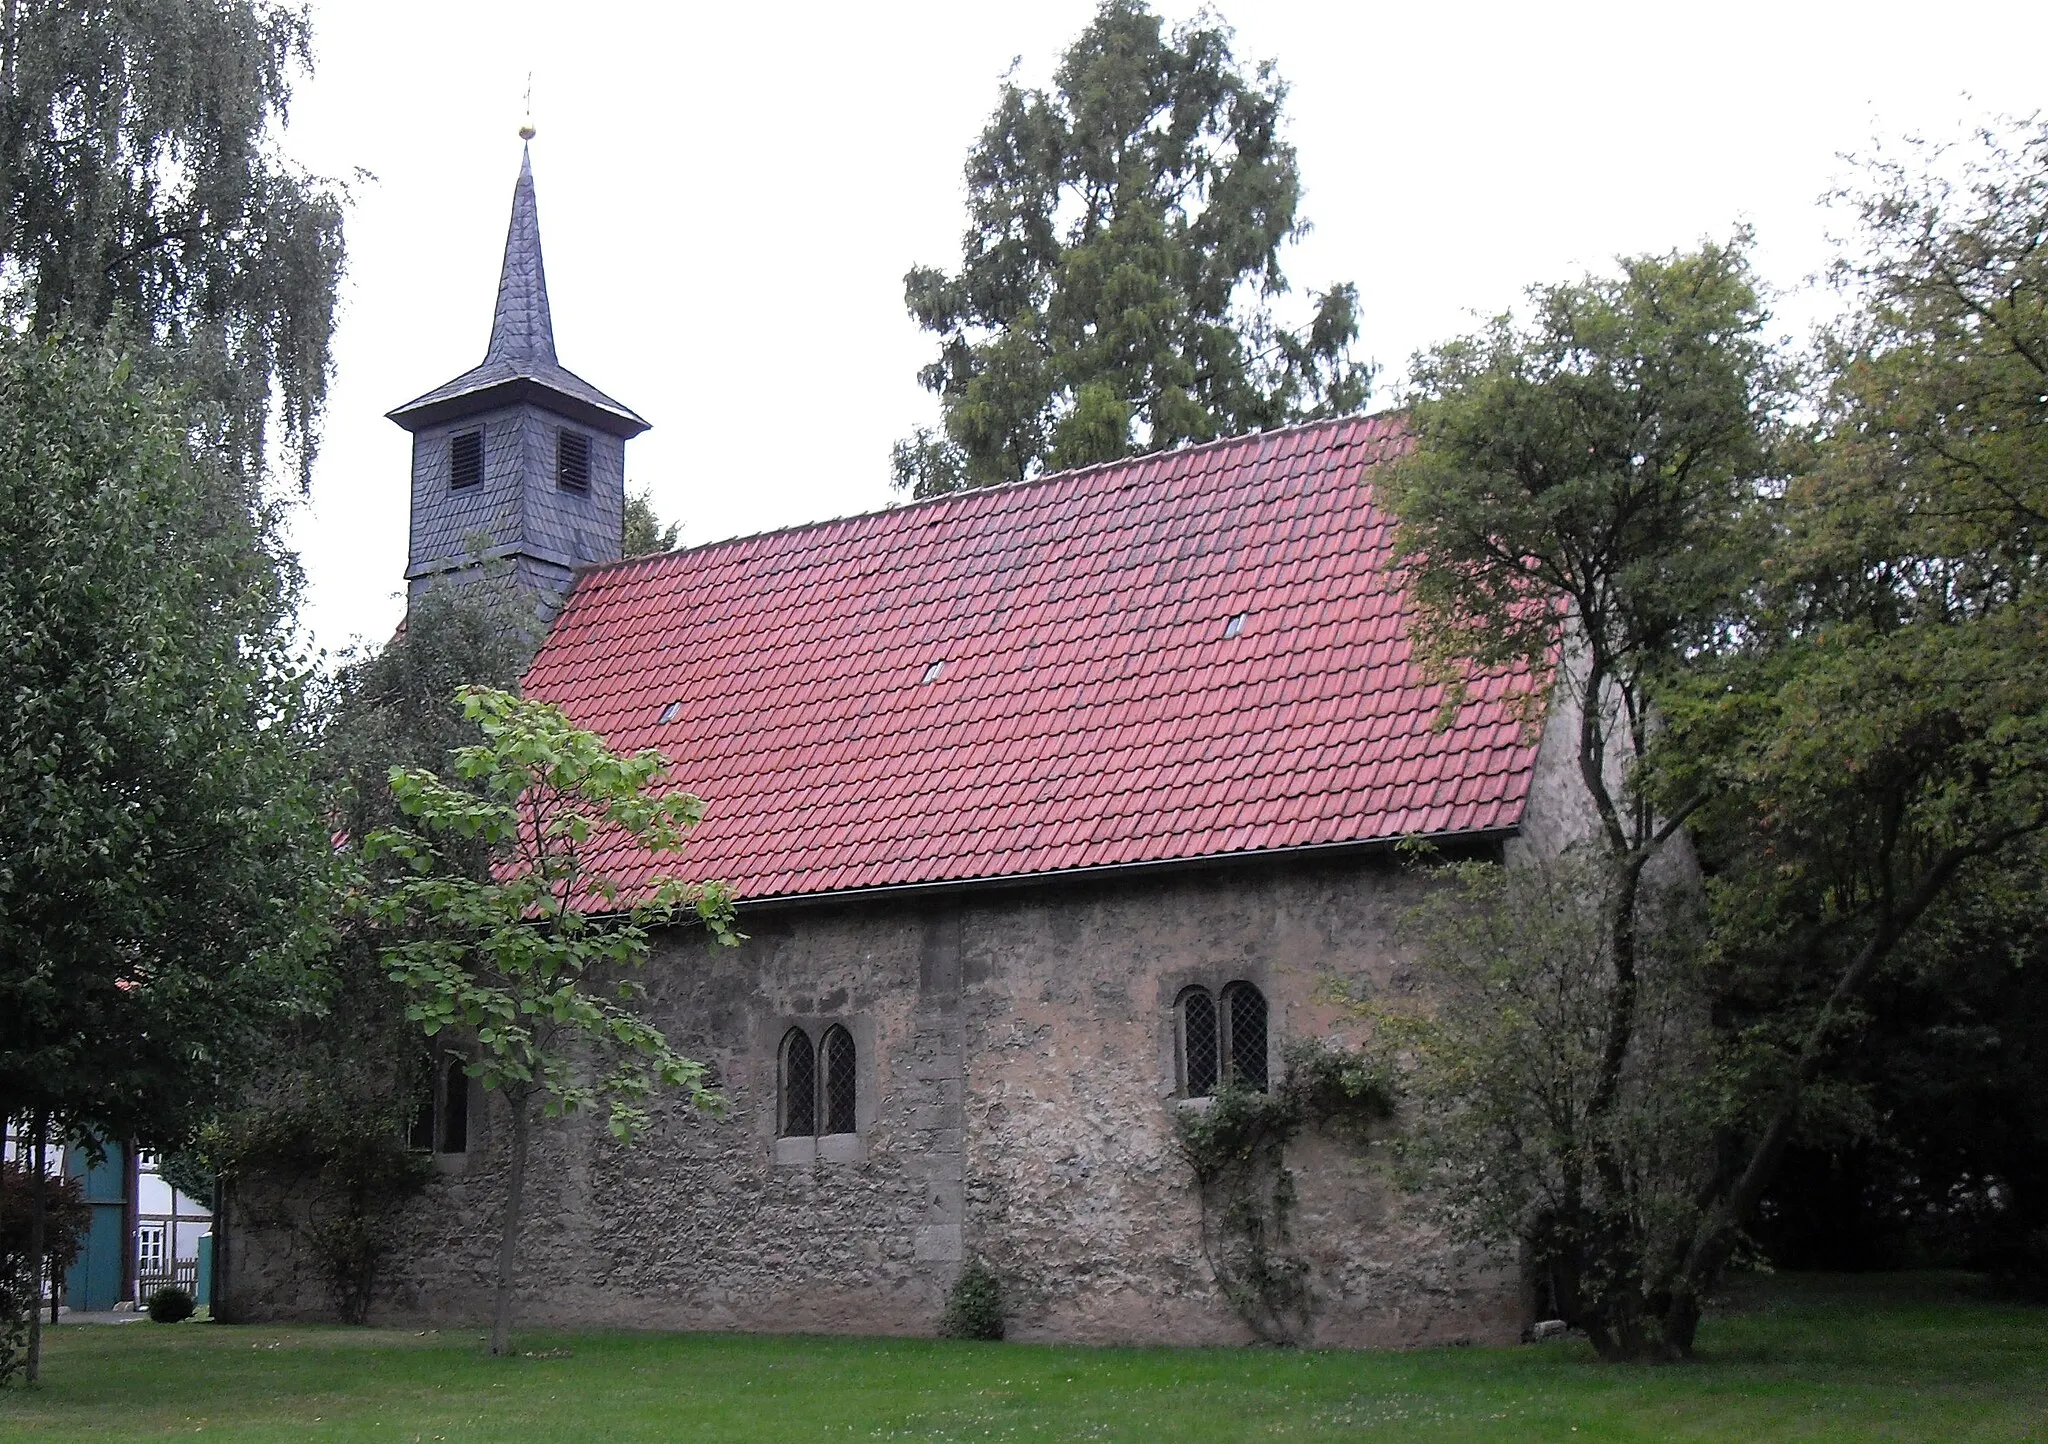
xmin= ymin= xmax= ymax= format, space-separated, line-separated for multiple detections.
xmin=229 ymin=858 xmax=1522 ymax=1346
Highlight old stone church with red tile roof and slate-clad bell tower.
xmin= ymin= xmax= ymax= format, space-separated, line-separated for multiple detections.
xmin=229 ymin=143 xmax=1569 ymax=1346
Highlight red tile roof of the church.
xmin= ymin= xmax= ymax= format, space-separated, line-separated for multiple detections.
xmin=526 ymin=416 xmax=1534 ymax=899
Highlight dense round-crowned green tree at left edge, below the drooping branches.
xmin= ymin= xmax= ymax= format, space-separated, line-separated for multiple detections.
xmin=0 ymin=338 xmax=328 ymax=1378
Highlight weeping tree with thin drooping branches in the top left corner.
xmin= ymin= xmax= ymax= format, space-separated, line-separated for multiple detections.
xmin=0 ymin=0 xmax=344 ymax=487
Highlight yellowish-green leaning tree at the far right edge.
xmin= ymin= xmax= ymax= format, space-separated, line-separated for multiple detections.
xmin=1657 ymin=112 xmax=2048 ymax=1307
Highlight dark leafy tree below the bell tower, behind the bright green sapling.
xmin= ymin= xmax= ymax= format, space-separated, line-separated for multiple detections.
xmin=186 ymin=567 xmax=541 ymax=1323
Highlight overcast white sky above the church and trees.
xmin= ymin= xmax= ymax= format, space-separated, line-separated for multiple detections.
xmin=287 ymin=0 xmax=2048 ymax=651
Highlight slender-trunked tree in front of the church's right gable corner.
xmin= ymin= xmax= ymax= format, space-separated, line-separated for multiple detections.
xmin=1382 ymin=236 xmax=1784 ymax=1356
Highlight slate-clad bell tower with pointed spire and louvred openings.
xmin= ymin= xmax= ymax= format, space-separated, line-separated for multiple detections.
xmin=389 ymin=138 xmax=647 ymax=598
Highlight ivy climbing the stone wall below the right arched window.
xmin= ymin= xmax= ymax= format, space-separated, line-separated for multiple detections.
xmin=1174 ymin=1038 xmax=1395 ymax=1346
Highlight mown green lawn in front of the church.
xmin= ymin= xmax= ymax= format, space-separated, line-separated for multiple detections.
xmin=0 ymin=1276 xmax=2048 ymax=1444
